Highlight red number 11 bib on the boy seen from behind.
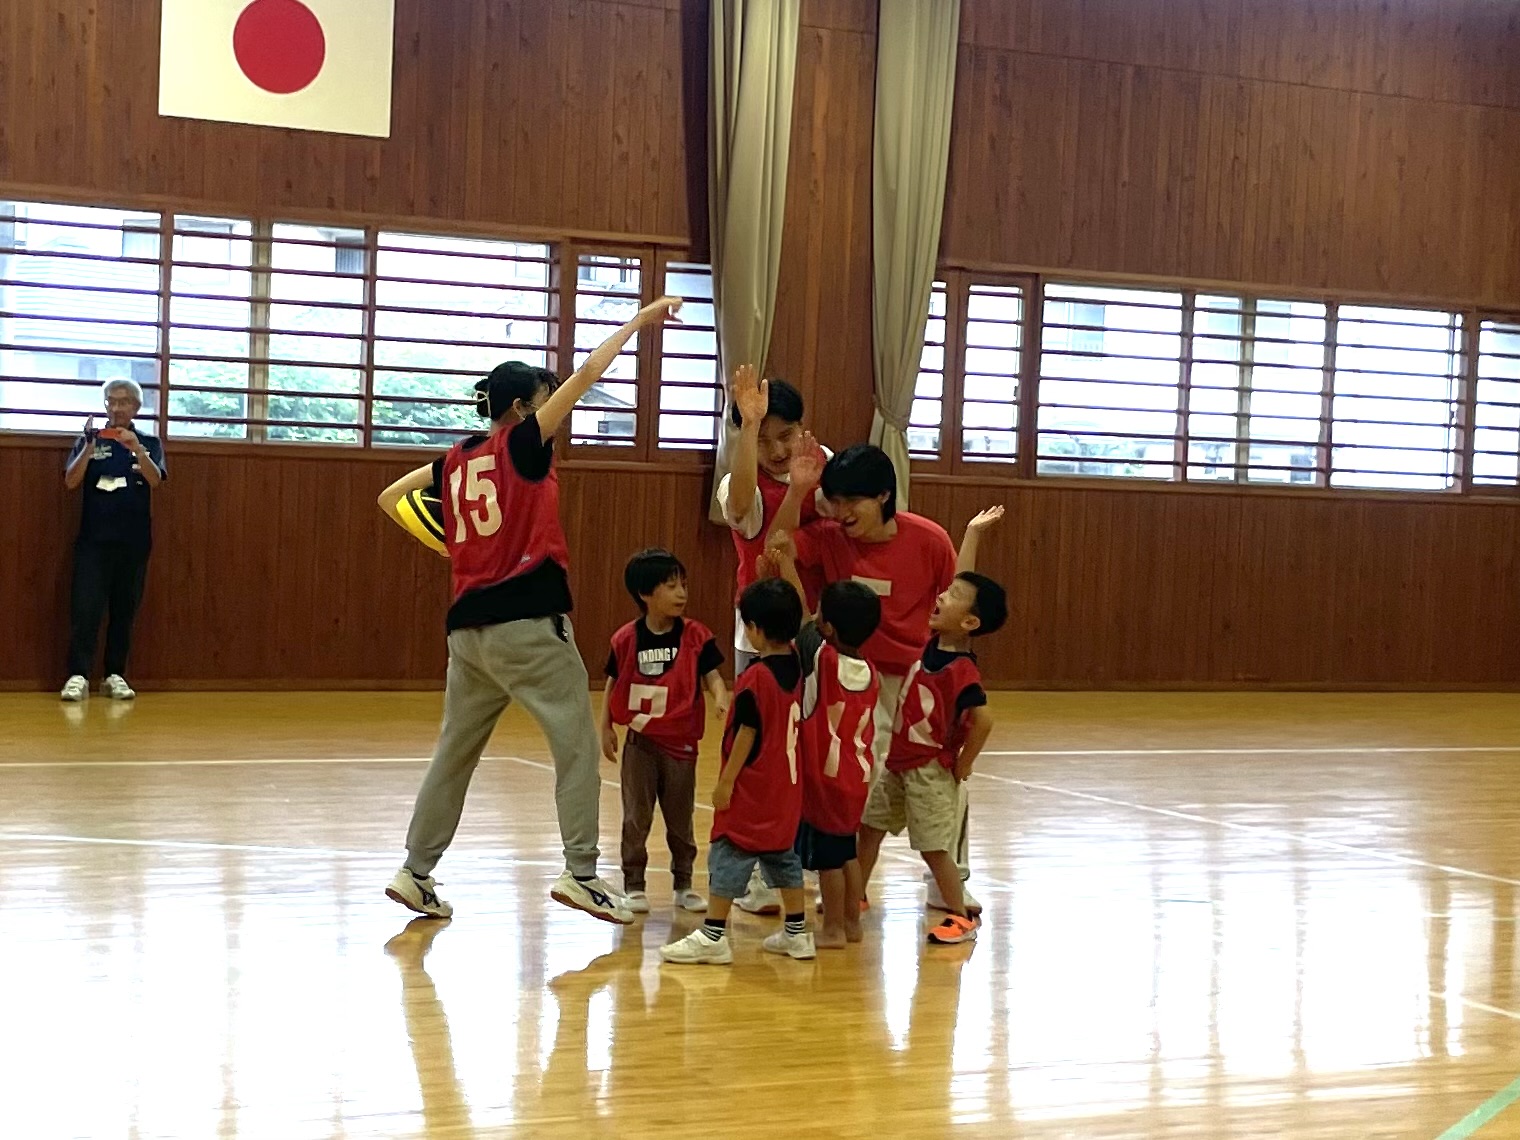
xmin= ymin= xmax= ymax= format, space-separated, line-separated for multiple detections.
xmin=800 ymin=644 xmax=882 ymax=834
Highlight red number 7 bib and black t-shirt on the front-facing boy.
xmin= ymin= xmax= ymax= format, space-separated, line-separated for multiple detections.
xmin=606 ymin=619 xmax=724 ymax=760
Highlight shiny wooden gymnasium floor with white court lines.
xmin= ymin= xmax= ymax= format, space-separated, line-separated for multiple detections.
xmin=0 ymin=695 xmax=1520 ymax=1140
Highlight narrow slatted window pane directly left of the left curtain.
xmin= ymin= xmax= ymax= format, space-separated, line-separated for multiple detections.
xmin=658 ymin=261 xmax=724 ymax=451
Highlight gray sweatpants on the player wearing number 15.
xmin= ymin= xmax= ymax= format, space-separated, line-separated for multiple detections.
xmin=406 ymin=617 xmax=602 ymax=877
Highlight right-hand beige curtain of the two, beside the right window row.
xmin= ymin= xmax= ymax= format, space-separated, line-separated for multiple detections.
xmin=871 ymin=0 xmax=961 ymax=508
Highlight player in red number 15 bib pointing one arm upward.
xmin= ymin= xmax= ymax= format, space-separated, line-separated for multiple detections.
xmin=380 ymin=296 xmax=681 ymax=924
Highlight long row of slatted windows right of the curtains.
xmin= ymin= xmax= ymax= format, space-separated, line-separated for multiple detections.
xmin=909 ymin=272 xmax=1520 ymax=491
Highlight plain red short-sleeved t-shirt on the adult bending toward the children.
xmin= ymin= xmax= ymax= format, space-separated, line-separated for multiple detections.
xmin=796 ymin=511 xmax=956 ymax=676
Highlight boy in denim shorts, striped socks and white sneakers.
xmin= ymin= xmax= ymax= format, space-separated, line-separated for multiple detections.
xmin=660 ymin=578 xmax=816 ymax=965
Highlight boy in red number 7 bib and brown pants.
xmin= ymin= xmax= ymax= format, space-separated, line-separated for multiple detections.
xmin=602 ymin=549 xmax=728 ymax=914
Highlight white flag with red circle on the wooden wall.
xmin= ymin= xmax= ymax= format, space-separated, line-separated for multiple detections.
xmin=159 ymin=0 xmax=395 ymax=138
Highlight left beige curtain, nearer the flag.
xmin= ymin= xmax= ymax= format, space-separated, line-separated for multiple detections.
xmin=708 ymin=0 xmax=801 ymax=523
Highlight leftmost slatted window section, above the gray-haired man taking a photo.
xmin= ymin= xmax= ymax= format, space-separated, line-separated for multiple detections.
xmin=0 ymin=201 xmax=161 ymax=432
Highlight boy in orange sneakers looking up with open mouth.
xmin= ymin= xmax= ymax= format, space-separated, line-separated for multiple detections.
xmin=860 ymin=572 xmax=1008 ymax=942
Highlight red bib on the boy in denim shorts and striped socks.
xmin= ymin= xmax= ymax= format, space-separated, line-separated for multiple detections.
xmin=713 ymin=654 xmax=803 ymax=851
